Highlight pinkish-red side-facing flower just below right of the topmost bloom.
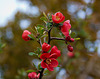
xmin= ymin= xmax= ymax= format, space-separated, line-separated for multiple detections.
xmin=61 ymin=20 xmax=71 ymax=37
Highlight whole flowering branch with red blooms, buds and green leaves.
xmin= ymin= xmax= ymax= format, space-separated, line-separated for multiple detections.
xmin=22 ymin=12 xmax=76 ymax=79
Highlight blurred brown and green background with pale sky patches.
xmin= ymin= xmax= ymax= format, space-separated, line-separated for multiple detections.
xmin=0 ymin=0 xmax=100 ymax=79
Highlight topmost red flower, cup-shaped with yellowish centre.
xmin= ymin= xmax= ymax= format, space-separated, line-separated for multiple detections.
xmin=52 ymin=12 xmax=65 ymax=23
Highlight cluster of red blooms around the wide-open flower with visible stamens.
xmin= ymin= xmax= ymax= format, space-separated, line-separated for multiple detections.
xmin=40 ymin=43 xmax=61 ymax=71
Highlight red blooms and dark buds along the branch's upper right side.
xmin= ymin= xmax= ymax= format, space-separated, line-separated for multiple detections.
xmin=52 ymin=12 xmax=74 ymax=56
